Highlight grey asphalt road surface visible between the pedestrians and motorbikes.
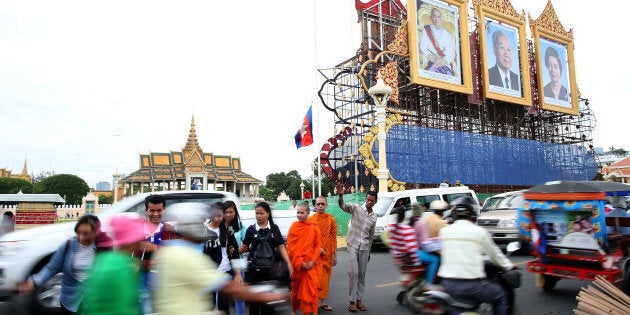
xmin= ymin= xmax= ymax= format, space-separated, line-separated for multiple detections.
xmin=319 ymin=250 xmax=589 ymax=315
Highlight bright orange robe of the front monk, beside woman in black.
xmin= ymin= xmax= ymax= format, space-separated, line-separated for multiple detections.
xmin=287 ymin=221 xmax=322 ymax=313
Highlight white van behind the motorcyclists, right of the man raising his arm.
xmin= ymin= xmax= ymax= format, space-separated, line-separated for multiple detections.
xmin=372 ymin=186 xmax=479 ymax=247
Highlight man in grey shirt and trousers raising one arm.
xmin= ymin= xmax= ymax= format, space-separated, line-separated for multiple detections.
xmin=337 ymin=183 xmax=378 ymax=312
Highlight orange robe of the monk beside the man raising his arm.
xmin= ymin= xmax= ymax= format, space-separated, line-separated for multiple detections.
xmin=308 ymin=212 xmax=337 ymax=300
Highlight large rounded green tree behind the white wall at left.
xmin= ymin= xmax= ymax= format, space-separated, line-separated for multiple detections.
xmin=33 ymin=174 xmax=90 ymax=205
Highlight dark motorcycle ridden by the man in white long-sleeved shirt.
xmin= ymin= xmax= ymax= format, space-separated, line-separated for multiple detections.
xmin=413 ymin=242 xmax=521 ymax=315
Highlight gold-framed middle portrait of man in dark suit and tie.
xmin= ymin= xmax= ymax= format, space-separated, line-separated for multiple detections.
xmin=475 ymin=1 xmax=532 ymax=106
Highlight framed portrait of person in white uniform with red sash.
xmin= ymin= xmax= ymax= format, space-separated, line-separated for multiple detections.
xmin=407 ymin=0 xmax=472 ymax=94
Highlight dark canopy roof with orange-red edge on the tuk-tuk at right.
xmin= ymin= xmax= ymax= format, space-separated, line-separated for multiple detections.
xmin=524 ymin=181 xmax=630 ymax=200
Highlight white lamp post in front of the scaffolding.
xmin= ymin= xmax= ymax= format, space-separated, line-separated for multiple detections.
xmin=368 ymin=76 xmax=393 ymax=192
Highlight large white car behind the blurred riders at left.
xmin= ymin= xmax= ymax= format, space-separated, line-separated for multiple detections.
xmin=0 ymin=190 xmax=240 ymax=314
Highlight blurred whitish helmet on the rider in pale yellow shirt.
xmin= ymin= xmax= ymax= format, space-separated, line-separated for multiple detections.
xmin=163 ymin=202 xmax=212 ymax=241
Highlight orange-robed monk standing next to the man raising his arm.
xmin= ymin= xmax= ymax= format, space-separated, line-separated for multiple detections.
xmin=308 ymin=196 xmax=337 ymax=311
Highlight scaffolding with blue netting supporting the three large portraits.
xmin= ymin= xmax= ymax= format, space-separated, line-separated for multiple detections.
xmin=318 ymin=1 xmax=596 ymax=193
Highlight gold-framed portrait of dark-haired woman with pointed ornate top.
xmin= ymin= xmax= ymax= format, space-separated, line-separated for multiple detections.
xmin=529 ymin=3 xmax=579 ymax=115
